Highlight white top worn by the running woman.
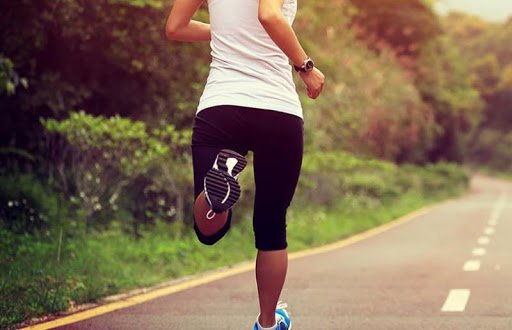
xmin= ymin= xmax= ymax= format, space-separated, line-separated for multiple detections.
xmin=197 ymin=0 xmax=302 ymax=118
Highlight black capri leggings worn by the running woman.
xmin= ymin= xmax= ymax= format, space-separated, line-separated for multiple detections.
xmin=192 ymin=105 xmax=304 ymax=251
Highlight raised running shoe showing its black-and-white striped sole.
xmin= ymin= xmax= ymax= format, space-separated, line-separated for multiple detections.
xmin=204 ymin=149 xmax=247 ymax=213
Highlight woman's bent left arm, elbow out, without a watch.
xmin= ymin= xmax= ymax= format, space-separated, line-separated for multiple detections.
xmin=165 ymin=0 xmax=211 ymax=41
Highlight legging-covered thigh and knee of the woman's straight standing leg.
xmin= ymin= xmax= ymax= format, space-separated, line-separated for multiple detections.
xmin=249 ymin=109 xmax=303 ymax=250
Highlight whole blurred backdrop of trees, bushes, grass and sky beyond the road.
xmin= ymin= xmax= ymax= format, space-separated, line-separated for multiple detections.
xmin=0 ymin=0 xmax=512 ymax=327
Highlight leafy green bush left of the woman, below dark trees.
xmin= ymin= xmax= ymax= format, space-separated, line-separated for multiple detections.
xmin=42 ymin=112 xmax=192 ymax=235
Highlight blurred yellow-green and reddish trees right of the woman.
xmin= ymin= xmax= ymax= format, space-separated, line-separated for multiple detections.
xmin=295 ymin=0 xmax=482 ymax=163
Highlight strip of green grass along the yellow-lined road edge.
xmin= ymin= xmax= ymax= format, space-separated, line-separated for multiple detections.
xmin=0 ymin=190 xmax=462 ymax=327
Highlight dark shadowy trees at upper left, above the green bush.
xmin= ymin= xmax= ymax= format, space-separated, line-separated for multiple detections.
xmin=0 ymin=0 xmax=209 ymax=165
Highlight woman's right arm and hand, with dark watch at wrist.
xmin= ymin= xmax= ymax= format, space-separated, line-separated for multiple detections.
xmin=258 ymin=0 xmax=325 ymax=99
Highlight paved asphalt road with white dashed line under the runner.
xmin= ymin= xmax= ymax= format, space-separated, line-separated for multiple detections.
xmin=53 ymin=177 xmax=512 ymax=330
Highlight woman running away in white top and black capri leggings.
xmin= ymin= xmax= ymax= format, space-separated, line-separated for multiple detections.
xmin=166 ymin=0 xmax=324 ymax=330
